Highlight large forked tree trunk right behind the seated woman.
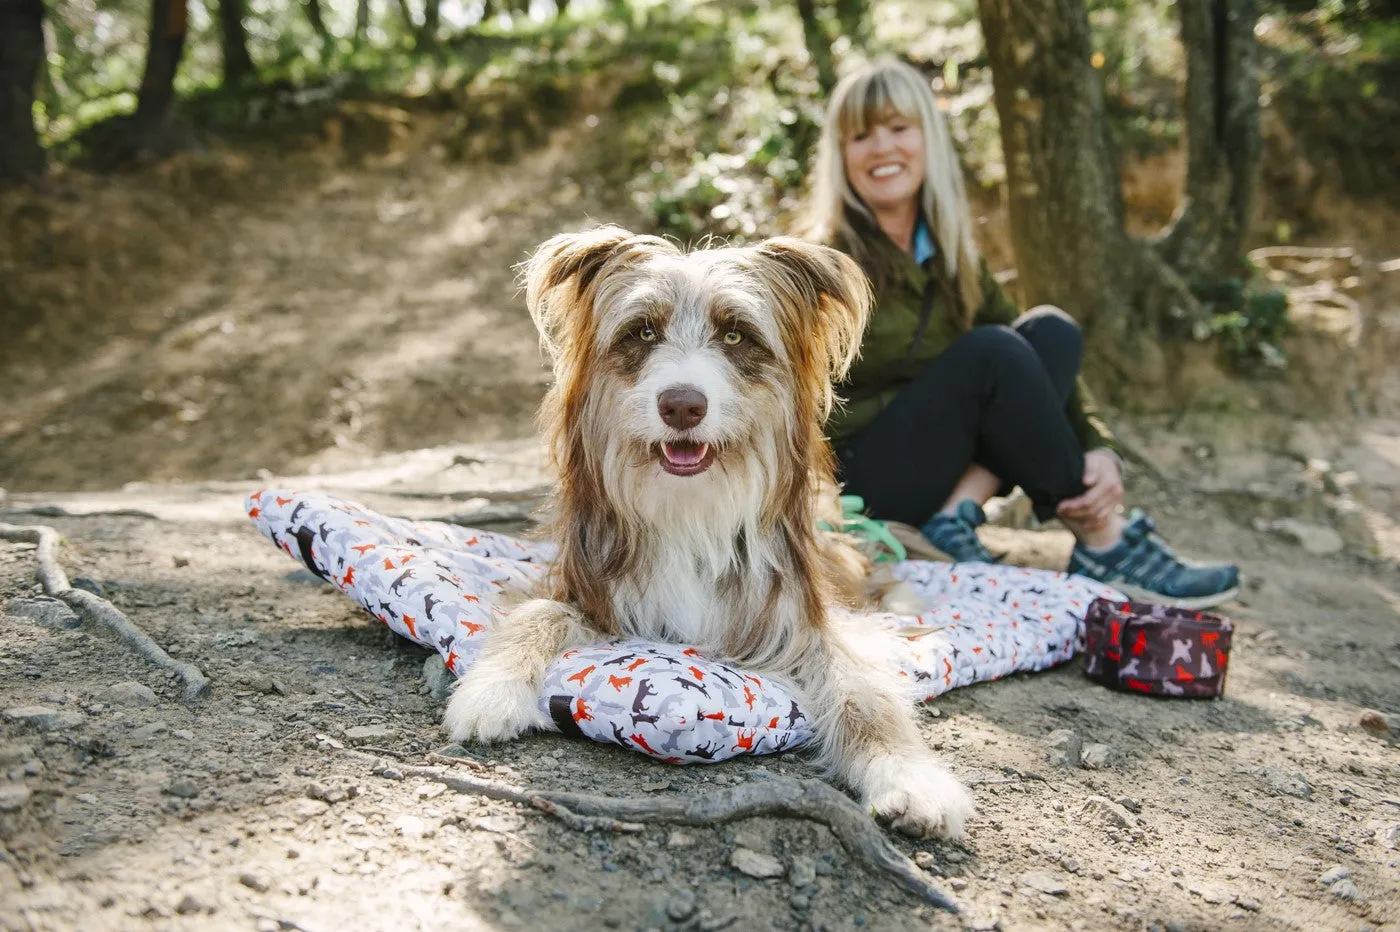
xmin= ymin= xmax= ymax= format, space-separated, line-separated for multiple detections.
xmin=979 ymin=0 xmax=1259 ymax=379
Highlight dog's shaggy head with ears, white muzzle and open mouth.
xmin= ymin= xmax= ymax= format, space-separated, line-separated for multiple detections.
xmin=526 ymin=227 xmax=869 ymax=526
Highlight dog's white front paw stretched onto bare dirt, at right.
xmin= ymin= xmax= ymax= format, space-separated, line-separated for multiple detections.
xmin=862 ymin=754 xmax=973 ymax=840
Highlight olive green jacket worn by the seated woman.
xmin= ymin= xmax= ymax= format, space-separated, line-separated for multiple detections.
xmin=826 ymin=234 xmax=1117 ymax=451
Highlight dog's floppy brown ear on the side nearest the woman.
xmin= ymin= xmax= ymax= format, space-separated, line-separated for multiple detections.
xmin=755 ymin=236 xmax=874 ymax=381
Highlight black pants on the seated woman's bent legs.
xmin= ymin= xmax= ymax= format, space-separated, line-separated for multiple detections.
xmin=836 ymin=309 xmax=1084 ymax=526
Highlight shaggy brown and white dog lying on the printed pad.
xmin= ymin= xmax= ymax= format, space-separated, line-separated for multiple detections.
xmin=444 ymin=227 xmax=972 ymax=837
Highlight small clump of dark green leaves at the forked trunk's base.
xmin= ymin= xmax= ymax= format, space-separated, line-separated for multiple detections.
xmin=1191 ymin=278 xmax=1292 ymax=369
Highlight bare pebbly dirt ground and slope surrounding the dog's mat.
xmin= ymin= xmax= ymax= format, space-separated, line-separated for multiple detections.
xmin=0 ymin=103 xmax=1400 ymax=932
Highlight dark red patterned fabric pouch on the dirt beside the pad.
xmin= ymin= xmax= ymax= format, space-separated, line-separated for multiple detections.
xmin=1084 ymin=599 xmax=1235 ymax=698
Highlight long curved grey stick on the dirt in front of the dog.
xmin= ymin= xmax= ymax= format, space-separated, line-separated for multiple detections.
xmin=386 ymin=767 xmax=958 ymax=912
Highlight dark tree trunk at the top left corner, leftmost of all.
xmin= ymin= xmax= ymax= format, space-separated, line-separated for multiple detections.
xmin=0 ymin=0 xmax=48 ymax=182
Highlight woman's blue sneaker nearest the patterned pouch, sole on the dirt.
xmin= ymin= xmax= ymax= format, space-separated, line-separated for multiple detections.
xmin=1065 ymin=512 xmax=1239 ymax=609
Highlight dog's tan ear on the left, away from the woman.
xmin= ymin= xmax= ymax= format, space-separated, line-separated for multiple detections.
xmin=522 ymin=225 xmax=671 ymax=360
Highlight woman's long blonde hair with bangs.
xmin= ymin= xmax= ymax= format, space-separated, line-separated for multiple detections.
xmin=804 ymin=59 xmax=983 ymax=326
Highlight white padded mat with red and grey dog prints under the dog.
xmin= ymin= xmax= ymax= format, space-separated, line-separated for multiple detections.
xmin=245 ymin=490 xmax=1124 ymax=763
